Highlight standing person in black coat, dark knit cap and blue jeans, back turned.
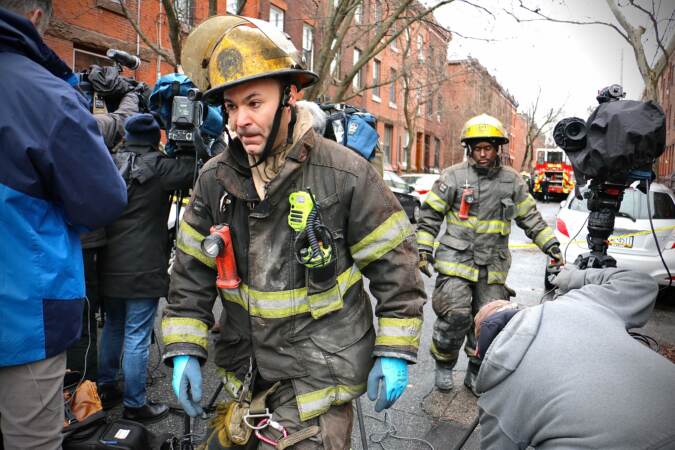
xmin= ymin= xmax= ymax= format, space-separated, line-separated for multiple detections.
xmin=98 ymin=114 xmax=196 ymax=422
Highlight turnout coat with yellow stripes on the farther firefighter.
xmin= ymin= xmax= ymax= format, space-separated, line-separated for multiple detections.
xmin=417 ymin=158 xmax=558 ymax=284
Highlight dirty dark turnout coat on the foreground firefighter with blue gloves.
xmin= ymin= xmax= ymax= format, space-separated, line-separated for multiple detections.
xmin=162 ymin=130 xmax=426 ymax=420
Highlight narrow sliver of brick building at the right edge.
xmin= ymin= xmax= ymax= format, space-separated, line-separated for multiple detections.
xmin=656 ymin=54 xmax=675 ymax=188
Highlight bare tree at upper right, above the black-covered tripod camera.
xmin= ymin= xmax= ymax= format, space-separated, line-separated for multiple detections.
xmin=505 ymin=0 xmax=675 ymax=101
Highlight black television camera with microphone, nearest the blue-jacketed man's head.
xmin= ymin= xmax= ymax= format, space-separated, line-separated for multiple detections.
xmin=78 ymin=48 xmax=148 ymax=114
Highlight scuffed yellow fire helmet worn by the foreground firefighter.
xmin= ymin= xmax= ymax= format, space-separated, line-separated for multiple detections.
xmin=182 ymin=15 xmax=318 ymax=103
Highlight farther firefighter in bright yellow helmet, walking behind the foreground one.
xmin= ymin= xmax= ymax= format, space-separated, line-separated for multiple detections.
xmin=417 ymin=114 xmax=562 ymax=394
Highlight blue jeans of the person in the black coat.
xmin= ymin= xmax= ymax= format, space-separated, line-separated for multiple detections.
xmin=98 ymin=297 xmax=158 ymax=408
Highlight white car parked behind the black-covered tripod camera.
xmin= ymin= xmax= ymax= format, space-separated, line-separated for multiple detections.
xmin=546 ymin=183 xmax=675 ymax=287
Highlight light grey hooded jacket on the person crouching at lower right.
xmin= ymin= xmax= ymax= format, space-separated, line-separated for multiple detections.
xmin=477 ymin=269 xmax=675 ymax=450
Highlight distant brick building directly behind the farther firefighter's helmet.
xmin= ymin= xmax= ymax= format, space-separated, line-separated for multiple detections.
xmin=445 ymin=58 xmax=527 ymax=168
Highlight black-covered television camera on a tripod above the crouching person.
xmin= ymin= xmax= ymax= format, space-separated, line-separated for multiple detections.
xmin=553 ymin=84 xmax=666 ymax=269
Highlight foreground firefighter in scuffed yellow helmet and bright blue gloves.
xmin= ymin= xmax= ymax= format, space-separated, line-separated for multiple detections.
xmin=162 ymin=16 xmax=426 ymax=450
